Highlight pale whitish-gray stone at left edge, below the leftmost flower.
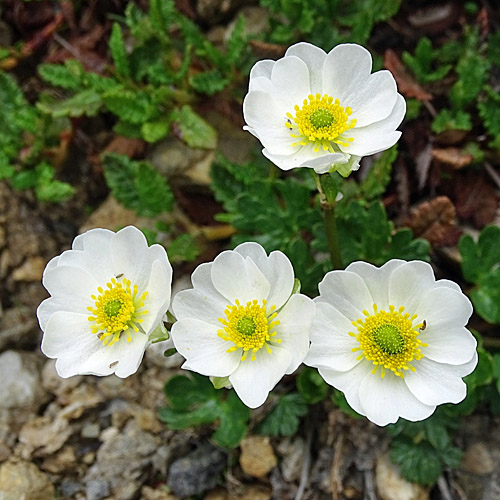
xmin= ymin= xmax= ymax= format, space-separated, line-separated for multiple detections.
xmin=0 ymin=351 xmax=45 ymax=410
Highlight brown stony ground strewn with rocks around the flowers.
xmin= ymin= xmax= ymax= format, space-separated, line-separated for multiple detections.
xmin=0 ymin=0 xmax=500 ymax=500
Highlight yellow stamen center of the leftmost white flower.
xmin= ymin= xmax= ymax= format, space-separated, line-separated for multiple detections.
xmin=87 ymin=278 xmax=148 ymax=346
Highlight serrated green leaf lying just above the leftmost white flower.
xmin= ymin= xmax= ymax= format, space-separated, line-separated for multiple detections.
xmin=102 ymin=153 xmax=173 ymax=217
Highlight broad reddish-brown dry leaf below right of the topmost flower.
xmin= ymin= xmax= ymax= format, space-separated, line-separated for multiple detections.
xmin=406 ymin=196 xmax=458 ymax=246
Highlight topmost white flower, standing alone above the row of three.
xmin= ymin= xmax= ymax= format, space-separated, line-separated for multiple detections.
xmin=243 ymin=43 xmax=406 ymax=176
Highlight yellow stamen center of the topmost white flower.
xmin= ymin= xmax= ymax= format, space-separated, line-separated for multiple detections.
xmin=285 ymin=94 xmax=356 ymax=153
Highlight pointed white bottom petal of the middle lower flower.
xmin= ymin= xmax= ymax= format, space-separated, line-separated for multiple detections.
xmin=229 ymin=346 xmax=292 ymax=408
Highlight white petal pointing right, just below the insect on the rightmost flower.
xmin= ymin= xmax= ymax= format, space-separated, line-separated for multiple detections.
xmin=419 ymin=324 xmax=477 ymax=365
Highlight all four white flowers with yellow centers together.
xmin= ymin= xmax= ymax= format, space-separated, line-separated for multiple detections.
xmin=38 ymin=43 xmax=477 ymax=425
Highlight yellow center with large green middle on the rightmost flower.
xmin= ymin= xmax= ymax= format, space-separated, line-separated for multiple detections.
xmin=349 ymin=304 xmax=427 ymax=378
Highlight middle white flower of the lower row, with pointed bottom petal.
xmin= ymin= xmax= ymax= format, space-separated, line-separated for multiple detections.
xmin=171 ymin=243 xmax=315 ymax=408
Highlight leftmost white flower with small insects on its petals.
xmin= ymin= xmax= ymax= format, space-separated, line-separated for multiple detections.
xmin=37 ymin=226 xmax=172 ymax=377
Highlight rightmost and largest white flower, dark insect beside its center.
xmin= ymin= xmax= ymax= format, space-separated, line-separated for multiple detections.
xmin=304 ymin=260 xmax=477 ymax=425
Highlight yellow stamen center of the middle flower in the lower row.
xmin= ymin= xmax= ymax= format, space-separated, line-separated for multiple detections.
xmin=217 ymin=300 xmax=281 ymax=361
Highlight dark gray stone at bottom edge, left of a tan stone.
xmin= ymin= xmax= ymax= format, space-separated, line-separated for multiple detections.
xmin=167 ymin=443 xmax=226 ymax=498
